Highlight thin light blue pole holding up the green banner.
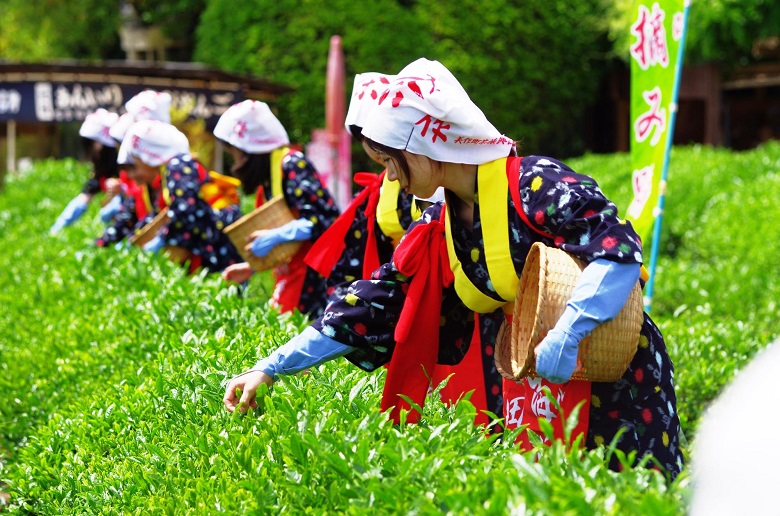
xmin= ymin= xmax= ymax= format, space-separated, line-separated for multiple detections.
xmin=644 ymin=0 xmax=692 ymax=313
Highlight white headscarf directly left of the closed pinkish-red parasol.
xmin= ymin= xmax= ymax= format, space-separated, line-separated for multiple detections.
xmin=214 ymin=100 xmax=290 ymax=154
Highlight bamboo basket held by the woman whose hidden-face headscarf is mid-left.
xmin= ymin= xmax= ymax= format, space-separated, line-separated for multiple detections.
xmin=223 ymin=195 xmax=303 ymax=271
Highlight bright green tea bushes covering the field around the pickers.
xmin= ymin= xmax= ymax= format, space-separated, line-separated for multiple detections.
xmin=0 ymin=142 xmax=780 ymax=514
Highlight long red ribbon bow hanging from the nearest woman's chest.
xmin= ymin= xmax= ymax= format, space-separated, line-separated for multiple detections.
xmin=381 ymin=220 xmax=454 ymax=423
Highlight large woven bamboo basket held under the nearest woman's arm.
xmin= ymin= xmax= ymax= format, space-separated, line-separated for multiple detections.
xmin=495 ymin=243 xmax=644 ymax=382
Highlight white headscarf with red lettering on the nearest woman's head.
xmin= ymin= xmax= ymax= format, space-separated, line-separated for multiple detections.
xmin=363 ymin=58 xmax=514 ymax=165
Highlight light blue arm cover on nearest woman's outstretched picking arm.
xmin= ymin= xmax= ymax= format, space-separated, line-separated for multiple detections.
xmin=252 ymin=326 xmax=355 ymax=378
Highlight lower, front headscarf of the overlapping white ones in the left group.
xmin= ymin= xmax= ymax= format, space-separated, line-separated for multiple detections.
xmin=116 ymin=120 xmax=190 ymax=167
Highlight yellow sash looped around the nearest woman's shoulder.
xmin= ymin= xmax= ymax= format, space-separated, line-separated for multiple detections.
xmin=444 ymin=158 xmax=520 ymax=313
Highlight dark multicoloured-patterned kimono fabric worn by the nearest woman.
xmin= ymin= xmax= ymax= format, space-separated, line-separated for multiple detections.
xmin=314 ymin=156 xmax=683 ymax=476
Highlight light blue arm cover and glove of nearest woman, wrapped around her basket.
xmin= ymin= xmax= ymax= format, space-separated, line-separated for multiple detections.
xmin=536 ymin=258 xmax=640 ymax=383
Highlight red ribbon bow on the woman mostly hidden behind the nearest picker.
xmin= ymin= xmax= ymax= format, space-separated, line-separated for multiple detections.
xmin=305 ymin=172 xmax=385 ymax=279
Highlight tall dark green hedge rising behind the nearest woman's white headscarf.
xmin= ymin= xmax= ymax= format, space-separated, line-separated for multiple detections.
xmin=195 ymin=0 xmax=609 ymax=153
